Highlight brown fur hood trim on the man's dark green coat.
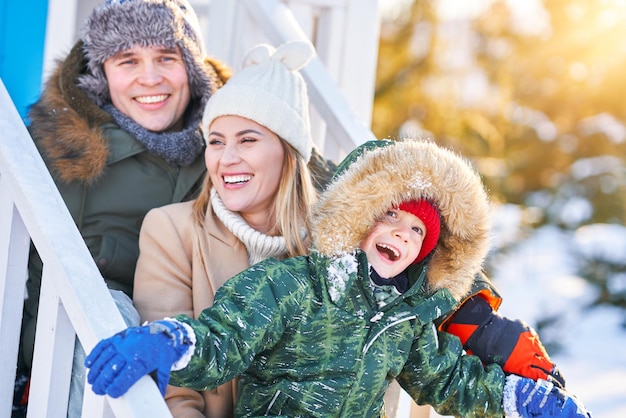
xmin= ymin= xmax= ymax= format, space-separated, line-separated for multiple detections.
xmin=28 ymin=41 xmax=230 ymax=183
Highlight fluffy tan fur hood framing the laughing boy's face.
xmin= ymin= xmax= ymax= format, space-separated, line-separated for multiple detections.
xmin=312 ymin=139 xmax=491 ymax=300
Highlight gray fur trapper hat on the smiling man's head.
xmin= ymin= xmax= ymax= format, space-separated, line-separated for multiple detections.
xmin=79 ymin=0 xmax=218 ymax=106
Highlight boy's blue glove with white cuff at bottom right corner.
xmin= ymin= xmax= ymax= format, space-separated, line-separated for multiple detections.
xmin=502 ymin=374 xmax=591 ymax=418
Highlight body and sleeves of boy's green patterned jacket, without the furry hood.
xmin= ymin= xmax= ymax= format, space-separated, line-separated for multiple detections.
xmin=170 ymin=251 xmax=504 ymax=417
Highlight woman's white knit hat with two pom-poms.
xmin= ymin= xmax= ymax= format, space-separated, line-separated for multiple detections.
xmin=202 ymin=41 xmax=315 ymax=162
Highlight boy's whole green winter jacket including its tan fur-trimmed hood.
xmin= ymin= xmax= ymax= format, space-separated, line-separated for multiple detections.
xmin=170 ymin=141 xmax=504 ymax=417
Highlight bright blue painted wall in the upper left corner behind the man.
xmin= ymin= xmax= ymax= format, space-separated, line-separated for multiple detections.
xmin=0 ymin=0 xmax=48 ymax=119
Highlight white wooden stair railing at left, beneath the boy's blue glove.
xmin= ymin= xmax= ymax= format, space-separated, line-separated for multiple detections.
xmin=0 ymin=77 xmax=169 ymax=417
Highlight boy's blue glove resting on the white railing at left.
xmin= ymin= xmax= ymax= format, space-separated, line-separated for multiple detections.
xmin=85 ymin=320 xmax=193 ymax=398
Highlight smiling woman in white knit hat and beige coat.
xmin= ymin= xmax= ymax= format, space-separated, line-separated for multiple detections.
xmin=134 ymin=42 xmax=315 ymax=417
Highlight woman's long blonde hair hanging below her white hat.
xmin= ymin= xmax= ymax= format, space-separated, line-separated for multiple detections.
xmin=193 ymin=138 xmax=317 ymax=257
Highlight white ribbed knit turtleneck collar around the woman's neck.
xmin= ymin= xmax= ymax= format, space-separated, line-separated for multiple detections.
xmin=211 ymin=189 xmax=287 ymax=265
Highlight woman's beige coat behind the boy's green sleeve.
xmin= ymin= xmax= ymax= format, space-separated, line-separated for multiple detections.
xmin=134 ymin=202 xmax=249 ymax=418
